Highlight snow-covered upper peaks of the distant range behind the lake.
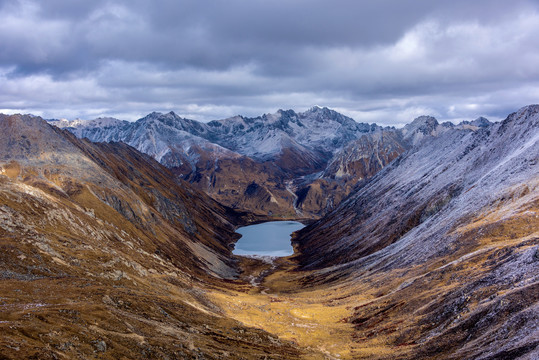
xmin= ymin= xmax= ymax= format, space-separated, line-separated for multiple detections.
xmin=49 ymin=107 xmax=381 ymax=164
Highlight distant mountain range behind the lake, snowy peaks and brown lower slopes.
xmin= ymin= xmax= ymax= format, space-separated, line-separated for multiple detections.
xmin=49 ymin=107 xmax=490 ymax=218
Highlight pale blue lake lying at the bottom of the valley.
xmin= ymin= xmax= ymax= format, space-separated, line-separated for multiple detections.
xmin=233 ymin=221 xmax=305 ymax=256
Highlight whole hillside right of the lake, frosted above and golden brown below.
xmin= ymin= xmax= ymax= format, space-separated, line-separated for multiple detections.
xmin=296 ymin=105 xmax=539 ymax=359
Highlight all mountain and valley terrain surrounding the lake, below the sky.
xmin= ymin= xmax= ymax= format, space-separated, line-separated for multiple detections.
xmin=0 ymin=105 xmax=539 ymax=360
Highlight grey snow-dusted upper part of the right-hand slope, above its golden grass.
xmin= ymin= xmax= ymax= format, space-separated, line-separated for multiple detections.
xmin=301 ymin=105 xmax=539 ymax=266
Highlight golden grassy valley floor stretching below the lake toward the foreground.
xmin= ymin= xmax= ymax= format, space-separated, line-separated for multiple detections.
xmin=211 ymin=257 xmax=353 ymax=359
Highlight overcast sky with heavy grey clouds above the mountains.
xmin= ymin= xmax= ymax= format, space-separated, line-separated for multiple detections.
xmin=0 ymin=0 xmax=539 ymax=126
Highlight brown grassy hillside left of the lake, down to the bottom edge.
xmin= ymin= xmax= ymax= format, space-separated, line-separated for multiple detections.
xmin=0 ymin=115 xmax=302 ymax=359
